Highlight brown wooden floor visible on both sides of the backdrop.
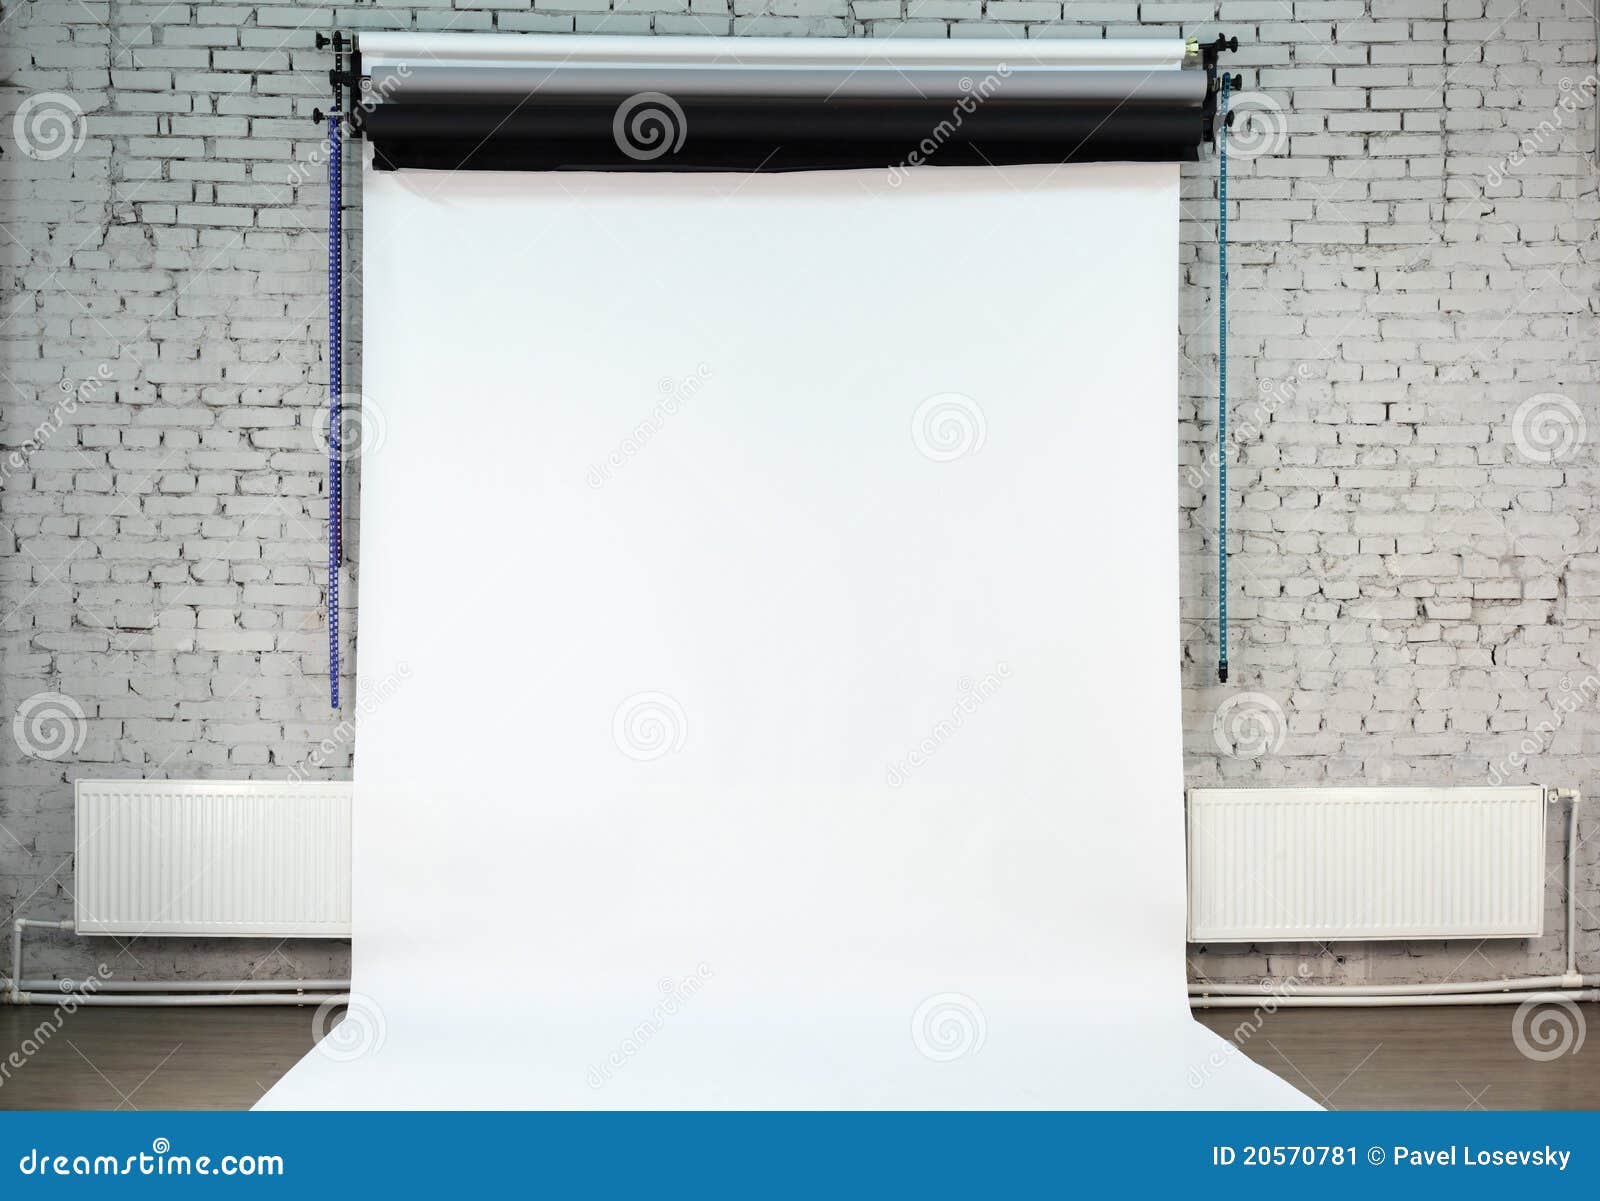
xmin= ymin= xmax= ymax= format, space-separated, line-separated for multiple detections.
xmin=0 ymin=1006 xmax=1600 ymax=1110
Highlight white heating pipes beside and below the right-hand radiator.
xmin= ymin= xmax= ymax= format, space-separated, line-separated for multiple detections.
xmin=1189 ymin=788 xmax=1600 ymax=1009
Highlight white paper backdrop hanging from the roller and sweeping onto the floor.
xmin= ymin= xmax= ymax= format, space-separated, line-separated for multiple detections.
xmin=262 ymin=165 xmax=1309 ymax=1108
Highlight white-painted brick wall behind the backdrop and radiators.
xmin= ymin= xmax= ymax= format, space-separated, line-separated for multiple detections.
xmin=0 ymin=0 xmax=1600 ymax=980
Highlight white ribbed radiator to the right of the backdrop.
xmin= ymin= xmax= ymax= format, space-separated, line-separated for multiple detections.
xmin=1189 ymin=787 xmax=1546 ymax=942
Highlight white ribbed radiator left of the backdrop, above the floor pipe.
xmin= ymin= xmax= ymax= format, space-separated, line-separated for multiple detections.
xmin=75 ymin=780 xmax=350 ymax=939
